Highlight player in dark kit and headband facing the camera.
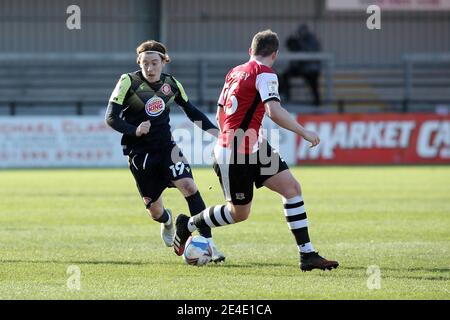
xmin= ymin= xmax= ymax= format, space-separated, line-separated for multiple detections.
xmin=105 ymin=40 xmax=225 ymax=262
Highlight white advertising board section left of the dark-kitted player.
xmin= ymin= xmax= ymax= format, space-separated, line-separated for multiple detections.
xmin=0 ymin=116 xmax=126 ymax=168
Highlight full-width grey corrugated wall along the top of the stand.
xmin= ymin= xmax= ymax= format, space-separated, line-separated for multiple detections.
xmin=0 ymin=0 xmax=450 ymax=65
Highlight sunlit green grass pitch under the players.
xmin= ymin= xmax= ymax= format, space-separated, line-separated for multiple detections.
xmin=0 ymin=166 xmax=450 ymax=300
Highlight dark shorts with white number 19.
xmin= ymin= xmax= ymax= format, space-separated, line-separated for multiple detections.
xmin=128 ymin=143 xmax=193 ymax=208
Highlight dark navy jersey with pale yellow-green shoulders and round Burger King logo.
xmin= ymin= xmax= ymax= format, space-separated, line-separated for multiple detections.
xmin=106 ymin=71 xmax=215 ymax=155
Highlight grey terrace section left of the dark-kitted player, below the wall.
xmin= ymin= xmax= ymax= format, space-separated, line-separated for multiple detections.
xmin=0 ymin=55 xmax=133 ymax=115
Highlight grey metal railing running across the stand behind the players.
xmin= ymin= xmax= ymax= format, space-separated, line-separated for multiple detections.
xmin=0 ymin=53 xmax=450 ymax=115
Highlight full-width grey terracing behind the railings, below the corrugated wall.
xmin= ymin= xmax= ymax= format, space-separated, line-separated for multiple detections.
xmin=0 ymin=56 xmax=450 ymax=114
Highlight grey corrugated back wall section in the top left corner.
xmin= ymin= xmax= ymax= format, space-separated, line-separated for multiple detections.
xmin=0 ymin=0 xmax=160 ymax=53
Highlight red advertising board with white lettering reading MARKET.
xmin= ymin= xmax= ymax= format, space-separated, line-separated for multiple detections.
xmin=296 ymin=113 xmax=450 ymax=164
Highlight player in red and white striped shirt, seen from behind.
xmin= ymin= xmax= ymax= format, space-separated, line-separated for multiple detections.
xmin=174 ymin=30 xmax=339 ymax=271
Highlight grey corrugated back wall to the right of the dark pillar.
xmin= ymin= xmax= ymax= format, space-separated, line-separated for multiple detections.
xmin=165 ymin=0 xmax=450 ymax=65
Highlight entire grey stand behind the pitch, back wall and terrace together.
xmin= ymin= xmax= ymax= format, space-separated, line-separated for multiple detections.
xmin=0 ymin=0 xmax=450 ymax=115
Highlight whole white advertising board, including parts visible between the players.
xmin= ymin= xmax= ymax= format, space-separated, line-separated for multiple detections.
xmin=0 ymin=114 xmax=296 ymax=168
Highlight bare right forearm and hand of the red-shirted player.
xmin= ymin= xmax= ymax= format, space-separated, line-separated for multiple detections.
xmin=264 ymin=100 xmax=320 ymax=147
